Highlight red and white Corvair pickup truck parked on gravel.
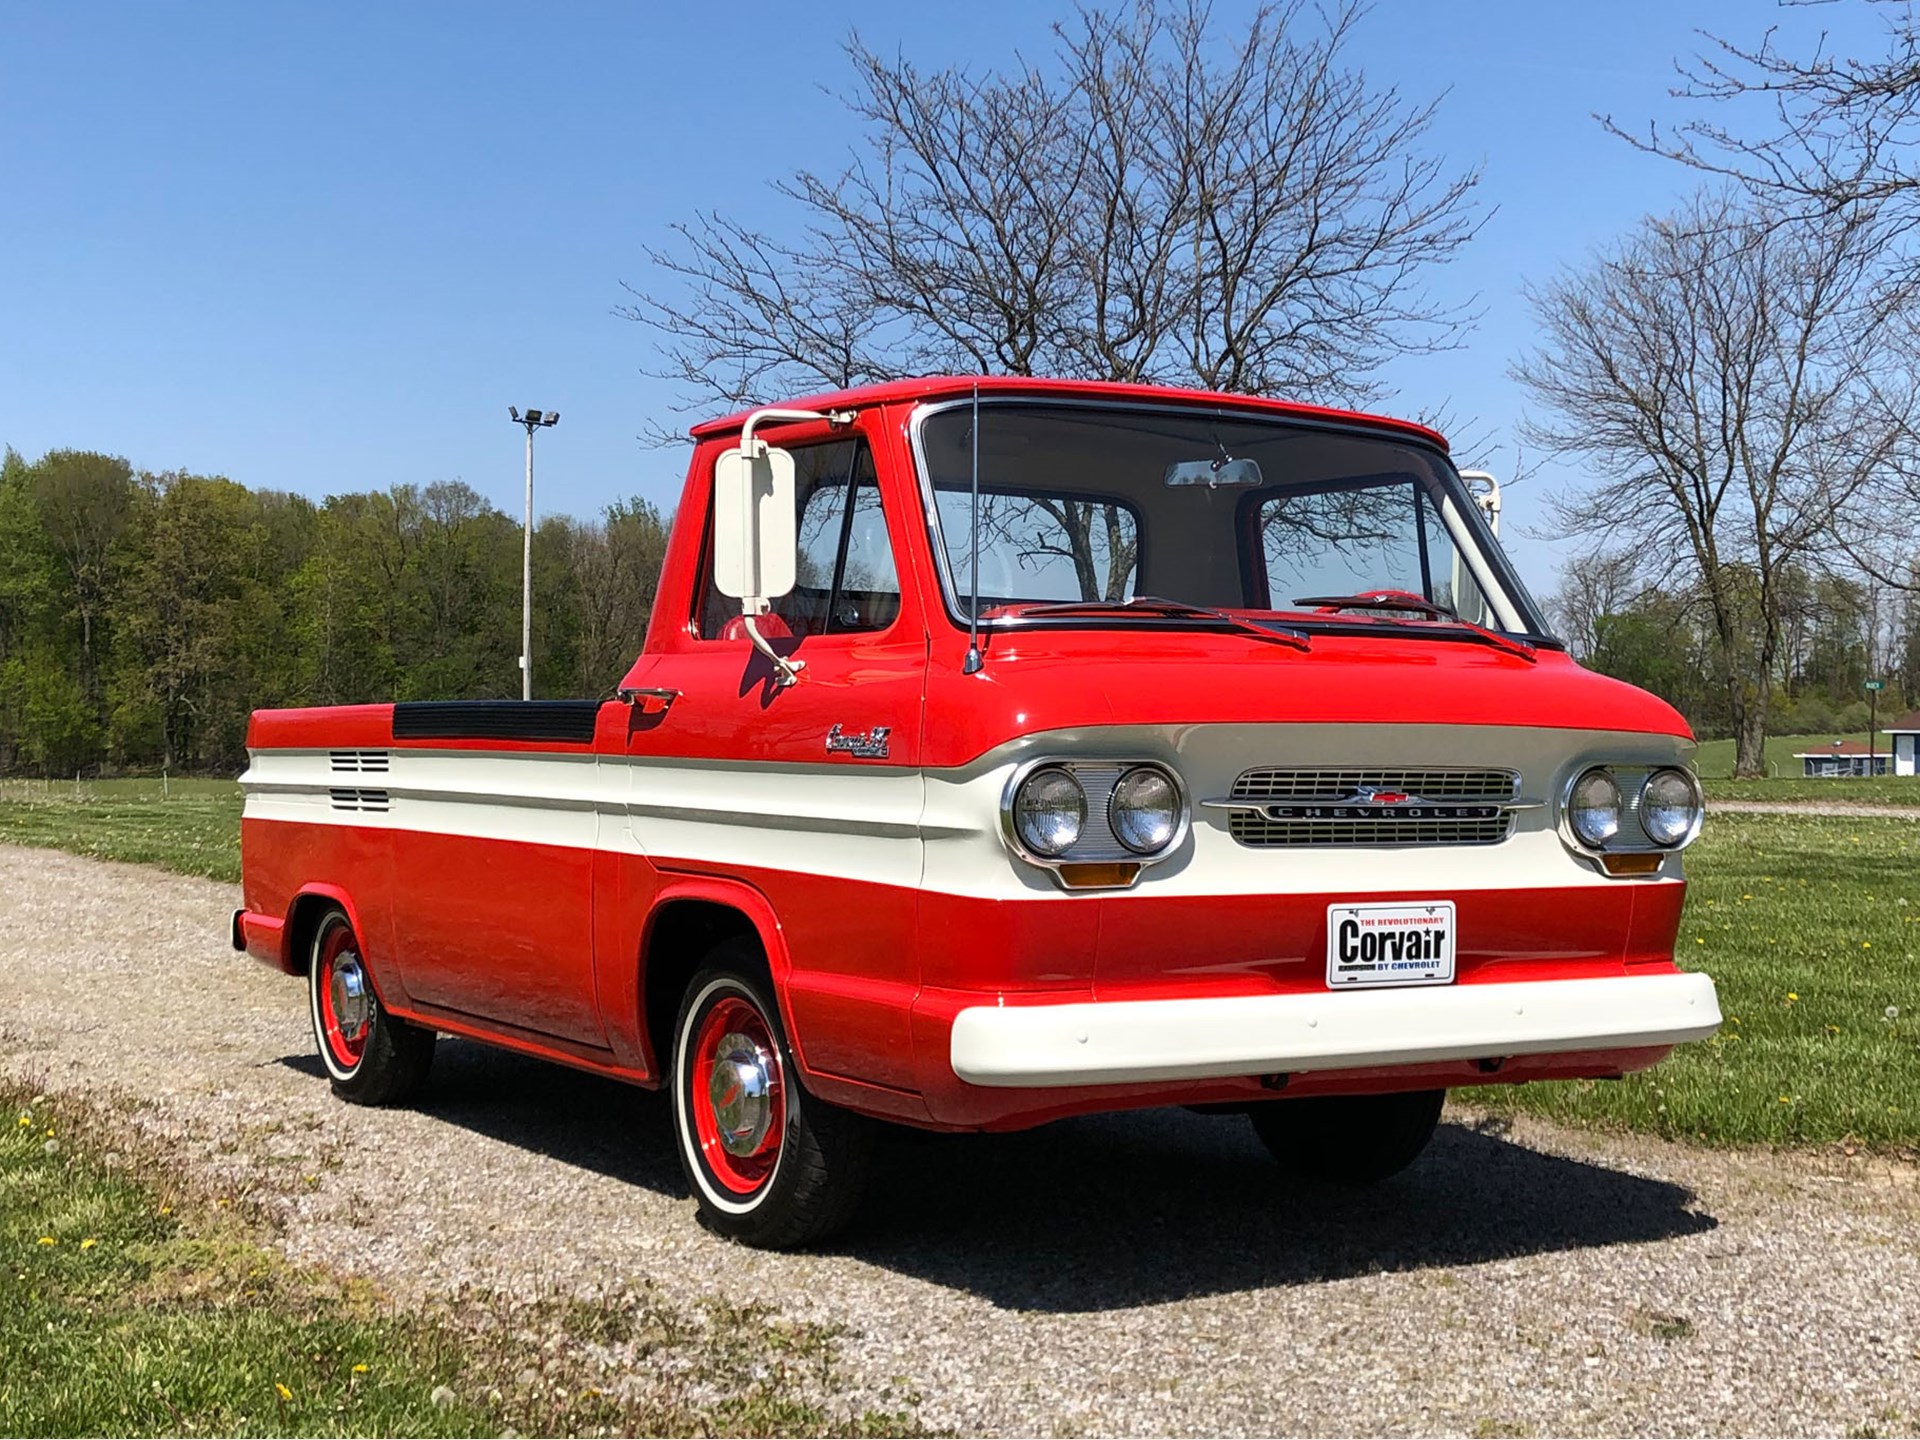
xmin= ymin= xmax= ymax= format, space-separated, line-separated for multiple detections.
xmin=232 ymin=378 xmax=1720 ymax=1246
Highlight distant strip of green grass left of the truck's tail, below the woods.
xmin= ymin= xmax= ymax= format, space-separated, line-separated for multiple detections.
xmin=0 ymin=780 xmax=240 ymax=881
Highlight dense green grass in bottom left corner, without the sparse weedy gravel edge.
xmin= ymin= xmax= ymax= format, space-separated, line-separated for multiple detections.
xmin=0 ymin=1091 xmax=501 ymax=1434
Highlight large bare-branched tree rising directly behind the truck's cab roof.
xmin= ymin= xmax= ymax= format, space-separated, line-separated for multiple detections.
xmin=622 ymin=0 xmax=1478 ymax=428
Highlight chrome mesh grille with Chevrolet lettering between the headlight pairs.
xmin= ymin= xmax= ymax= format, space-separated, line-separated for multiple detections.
xmin=1227 ymin=766 xmax=1521 ymax=849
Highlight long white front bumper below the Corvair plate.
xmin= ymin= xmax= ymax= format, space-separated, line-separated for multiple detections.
xmin=952 ymin=975 xmax=1720 ymax=1089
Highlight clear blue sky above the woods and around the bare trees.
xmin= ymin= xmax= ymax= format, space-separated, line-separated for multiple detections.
xmin=0 ymin=0 xmax=1878 ymax=591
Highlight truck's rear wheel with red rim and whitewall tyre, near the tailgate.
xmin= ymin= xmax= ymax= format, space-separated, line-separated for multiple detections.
xmin=307 ymin=908 xmax=434 ymax=1106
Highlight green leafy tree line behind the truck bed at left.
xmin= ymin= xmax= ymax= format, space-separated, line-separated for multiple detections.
xmin=0 ymin=449 xmax=668 ymax=776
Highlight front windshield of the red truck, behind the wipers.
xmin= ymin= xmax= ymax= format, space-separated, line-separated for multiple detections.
xmin=918 ymin=401 xmax=1546 ymax=636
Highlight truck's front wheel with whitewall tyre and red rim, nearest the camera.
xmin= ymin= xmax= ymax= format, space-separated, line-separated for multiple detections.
xmin=674 ymin=941 xmax=872 ymax=1250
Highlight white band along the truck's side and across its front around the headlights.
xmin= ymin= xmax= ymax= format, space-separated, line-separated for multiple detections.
xmin=240 ymin=724 xmax=1688 ymax=899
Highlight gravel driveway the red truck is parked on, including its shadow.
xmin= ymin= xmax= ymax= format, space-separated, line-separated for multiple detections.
xmin=0 ymin=847 xmax=1920 ymax=1434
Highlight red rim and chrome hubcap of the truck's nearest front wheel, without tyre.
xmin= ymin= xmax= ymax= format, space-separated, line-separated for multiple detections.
xmin=687 ymin=995 xmax=787 ymax=1194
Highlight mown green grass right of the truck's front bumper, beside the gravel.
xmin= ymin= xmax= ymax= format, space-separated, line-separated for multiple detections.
xmin=1497 ymin=814 xmax=1920 ymax=1150
